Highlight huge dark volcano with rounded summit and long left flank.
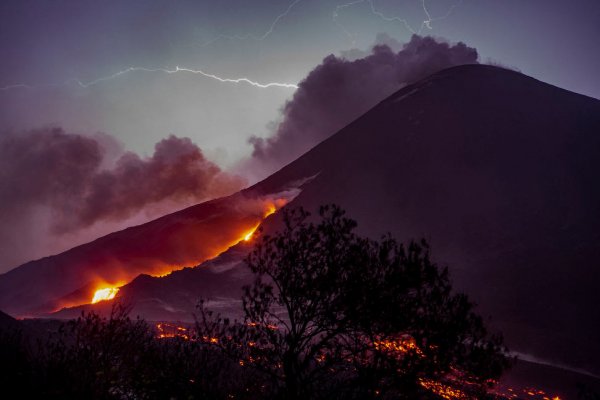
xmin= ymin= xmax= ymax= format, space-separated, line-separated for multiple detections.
xmin=0 ymin=65 xmax=600 ymax=374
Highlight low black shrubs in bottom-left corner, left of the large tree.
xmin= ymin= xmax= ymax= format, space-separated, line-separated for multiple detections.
xmin=0 ymin=303 xmax=252 ymax=400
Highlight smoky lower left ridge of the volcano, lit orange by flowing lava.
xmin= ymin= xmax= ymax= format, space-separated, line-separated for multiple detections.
xmin=0 ymin=190 xmax=296 ymax=317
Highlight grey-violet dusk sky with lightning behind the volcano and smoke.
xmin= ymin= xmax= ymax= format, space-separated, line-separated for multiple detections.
xmin=0 ymin=0 xmax=600 ymax=271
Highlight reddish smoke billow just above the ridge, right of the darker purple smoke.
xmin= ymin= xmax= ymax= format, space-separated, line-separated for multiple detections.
xmin=79 ymin=136 xmax=245 ymax=228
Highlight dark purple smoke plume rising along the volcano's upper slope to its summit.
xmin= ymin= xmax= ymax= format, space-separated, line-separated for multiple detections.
xmin=244 ymin=35 xmax=478 ymax=176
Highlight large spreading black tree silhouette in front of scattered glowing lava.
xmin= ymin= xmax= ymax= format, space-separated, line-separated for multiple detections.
xmin=197 ymin=206 xmax=507 ymax=399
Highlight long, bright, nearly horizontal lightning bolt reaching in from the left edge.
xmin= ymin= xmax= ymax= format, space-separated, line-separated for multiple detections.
xmin=0 ymin=66 xmax=298 ymax=91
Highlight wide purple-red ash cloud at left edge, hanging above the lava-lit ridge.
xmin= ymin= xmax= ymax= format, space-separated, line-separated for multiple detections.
xmin=0 ymin=128 xmax=246 ymax=271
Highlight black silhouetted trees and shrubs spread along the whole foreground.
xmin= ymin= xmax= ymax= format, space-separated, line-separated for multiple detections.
xmin=0 ymin=206 xmax=508 ymax=400
